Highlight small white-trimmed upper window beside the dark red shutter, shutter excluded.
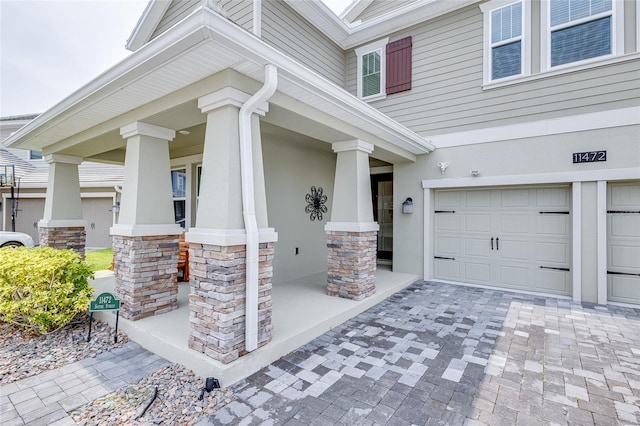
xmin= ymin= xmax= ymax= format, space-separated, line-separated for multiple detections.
xmin=355 ymin=38 xmax=389 ymax=100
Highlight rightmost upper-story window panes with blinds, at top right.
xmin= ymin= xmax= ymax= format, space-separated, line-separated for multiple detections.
xmin=548 ymin=0 xmax=614 ymax=67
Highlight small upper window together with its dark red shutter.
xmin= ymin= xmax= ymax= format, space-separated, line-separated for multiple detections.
xmin=356 ymin=36 xmax=413 ymax=100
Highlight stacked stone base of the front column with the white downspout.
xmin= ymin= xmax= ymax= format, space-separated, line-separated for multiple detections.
xmin=189 ymin=243 xmax=274 ymax=364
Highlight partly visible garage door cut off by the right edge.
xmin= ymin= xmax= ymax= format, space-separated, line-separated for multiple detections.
xmin=607 ymin=183 xmax=640 ymax=304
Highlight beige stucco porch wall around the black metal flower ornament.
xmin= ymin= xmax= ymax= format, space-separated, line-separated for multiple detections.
xmin=262 ymin=135 xmax=336 ymax=285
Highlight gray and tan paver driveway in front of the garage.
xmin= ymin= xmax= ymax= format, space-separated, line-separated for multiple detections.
xmin=200 ymin=281 xmax=640 ymax=425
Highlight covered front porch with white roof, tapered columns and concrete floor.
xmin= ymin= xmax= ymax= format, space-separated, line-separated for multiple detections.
xmin=3 ymin=3 xmax=433 ymax=380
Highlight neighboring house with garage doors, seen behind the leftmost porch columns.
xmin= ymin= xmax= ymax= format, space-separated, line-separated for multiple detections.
xmin=0 ymin=114 xmax=122 ymax=247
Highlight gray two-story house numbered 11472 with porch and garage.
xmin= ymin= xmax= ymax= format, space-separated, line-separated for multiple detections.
xmin=2 ymin=0 xmax=640 ymax=370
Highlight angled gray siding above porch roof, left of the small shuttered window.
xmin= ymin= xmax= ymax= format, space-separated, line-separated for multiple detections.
xmin=262 ymin=1 xmax=345 ymax=87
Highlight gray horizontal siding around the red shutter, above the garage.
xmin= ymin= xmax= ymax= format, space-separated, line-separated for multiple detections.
xmin=347 ymin=6 xmax=640 ymax=135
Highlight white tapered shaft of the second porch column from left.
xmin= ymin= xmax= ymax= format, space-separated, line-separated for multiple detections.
xmin=111 ymin=122 xmax=182 ymax=237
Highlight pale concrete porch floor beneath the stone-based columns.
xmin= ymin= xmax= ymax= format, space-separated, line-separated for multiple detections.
xmin=92 ymin=265 xmax=418 ymax=386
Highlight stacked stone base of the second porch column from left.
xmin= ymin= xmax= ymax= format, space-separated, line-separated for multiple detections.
xmin=113 ymin=235 xmax=178 ymax=321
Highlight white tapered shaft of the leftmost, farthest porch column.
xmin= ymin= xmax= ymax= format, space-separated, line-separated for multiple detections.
xmin=38 ymin=154 xmax=86 ymax=228
